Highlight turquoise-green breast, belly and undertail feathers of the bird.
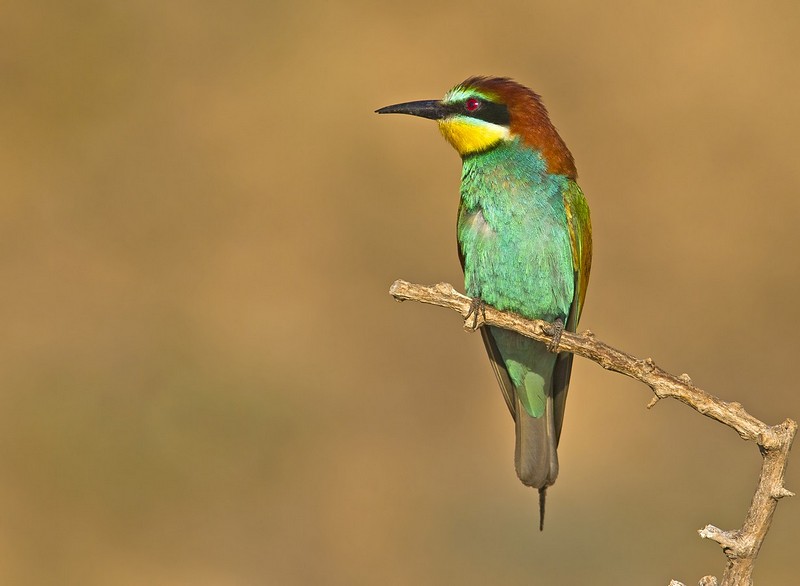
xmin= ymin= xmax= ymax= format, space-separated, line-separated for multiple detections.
xmin=458 ymin=140 xmax=575 ymax=406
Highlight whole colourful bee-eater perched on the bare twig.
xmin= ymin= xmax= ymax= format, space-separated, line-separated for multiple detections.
xmin=377 ymin=77 xmax=592 ymax=529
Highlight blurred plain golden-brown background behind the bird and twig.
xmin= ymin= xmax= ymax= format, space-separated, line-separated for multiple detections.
xmin=0 ymin=0 xmax=800 ymax=586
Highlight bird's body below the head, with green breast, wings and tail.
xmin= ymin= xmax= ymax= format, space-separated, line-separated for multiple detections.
xmin=458 ymin=139 xmax=588 ymax=502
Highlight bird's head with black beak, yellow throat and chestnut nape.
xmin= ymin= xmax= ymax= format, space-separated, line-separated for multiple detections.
xmin=376 ymin=77 xmax=576 ymax=178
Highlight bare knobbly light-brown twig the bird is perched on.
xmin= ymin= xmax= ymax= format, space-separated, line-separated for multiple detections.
xmin=389 ymin=280 xmax=797 ymax=586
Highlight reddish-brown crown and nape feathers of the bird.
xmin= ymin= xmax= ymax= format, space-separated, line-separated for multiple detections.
xmin=460 ymin=77 xmax=578 ymax=179
